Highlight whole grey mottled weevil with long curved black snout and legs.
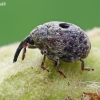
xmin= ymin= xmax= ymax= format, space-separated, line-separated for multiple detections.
xmin=13 ymin=21 xmax=94 ymax=78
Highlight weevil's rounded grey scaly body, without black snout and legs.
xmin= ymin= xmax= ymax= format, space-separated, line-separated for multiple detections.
xmin=30 ymin=22 xmax=91 ymax=62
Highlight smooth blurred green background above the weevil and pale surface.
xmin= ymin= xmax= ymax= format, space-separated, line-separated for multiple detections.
xmin=0 ymin=0 xmax=100 ymax=46
